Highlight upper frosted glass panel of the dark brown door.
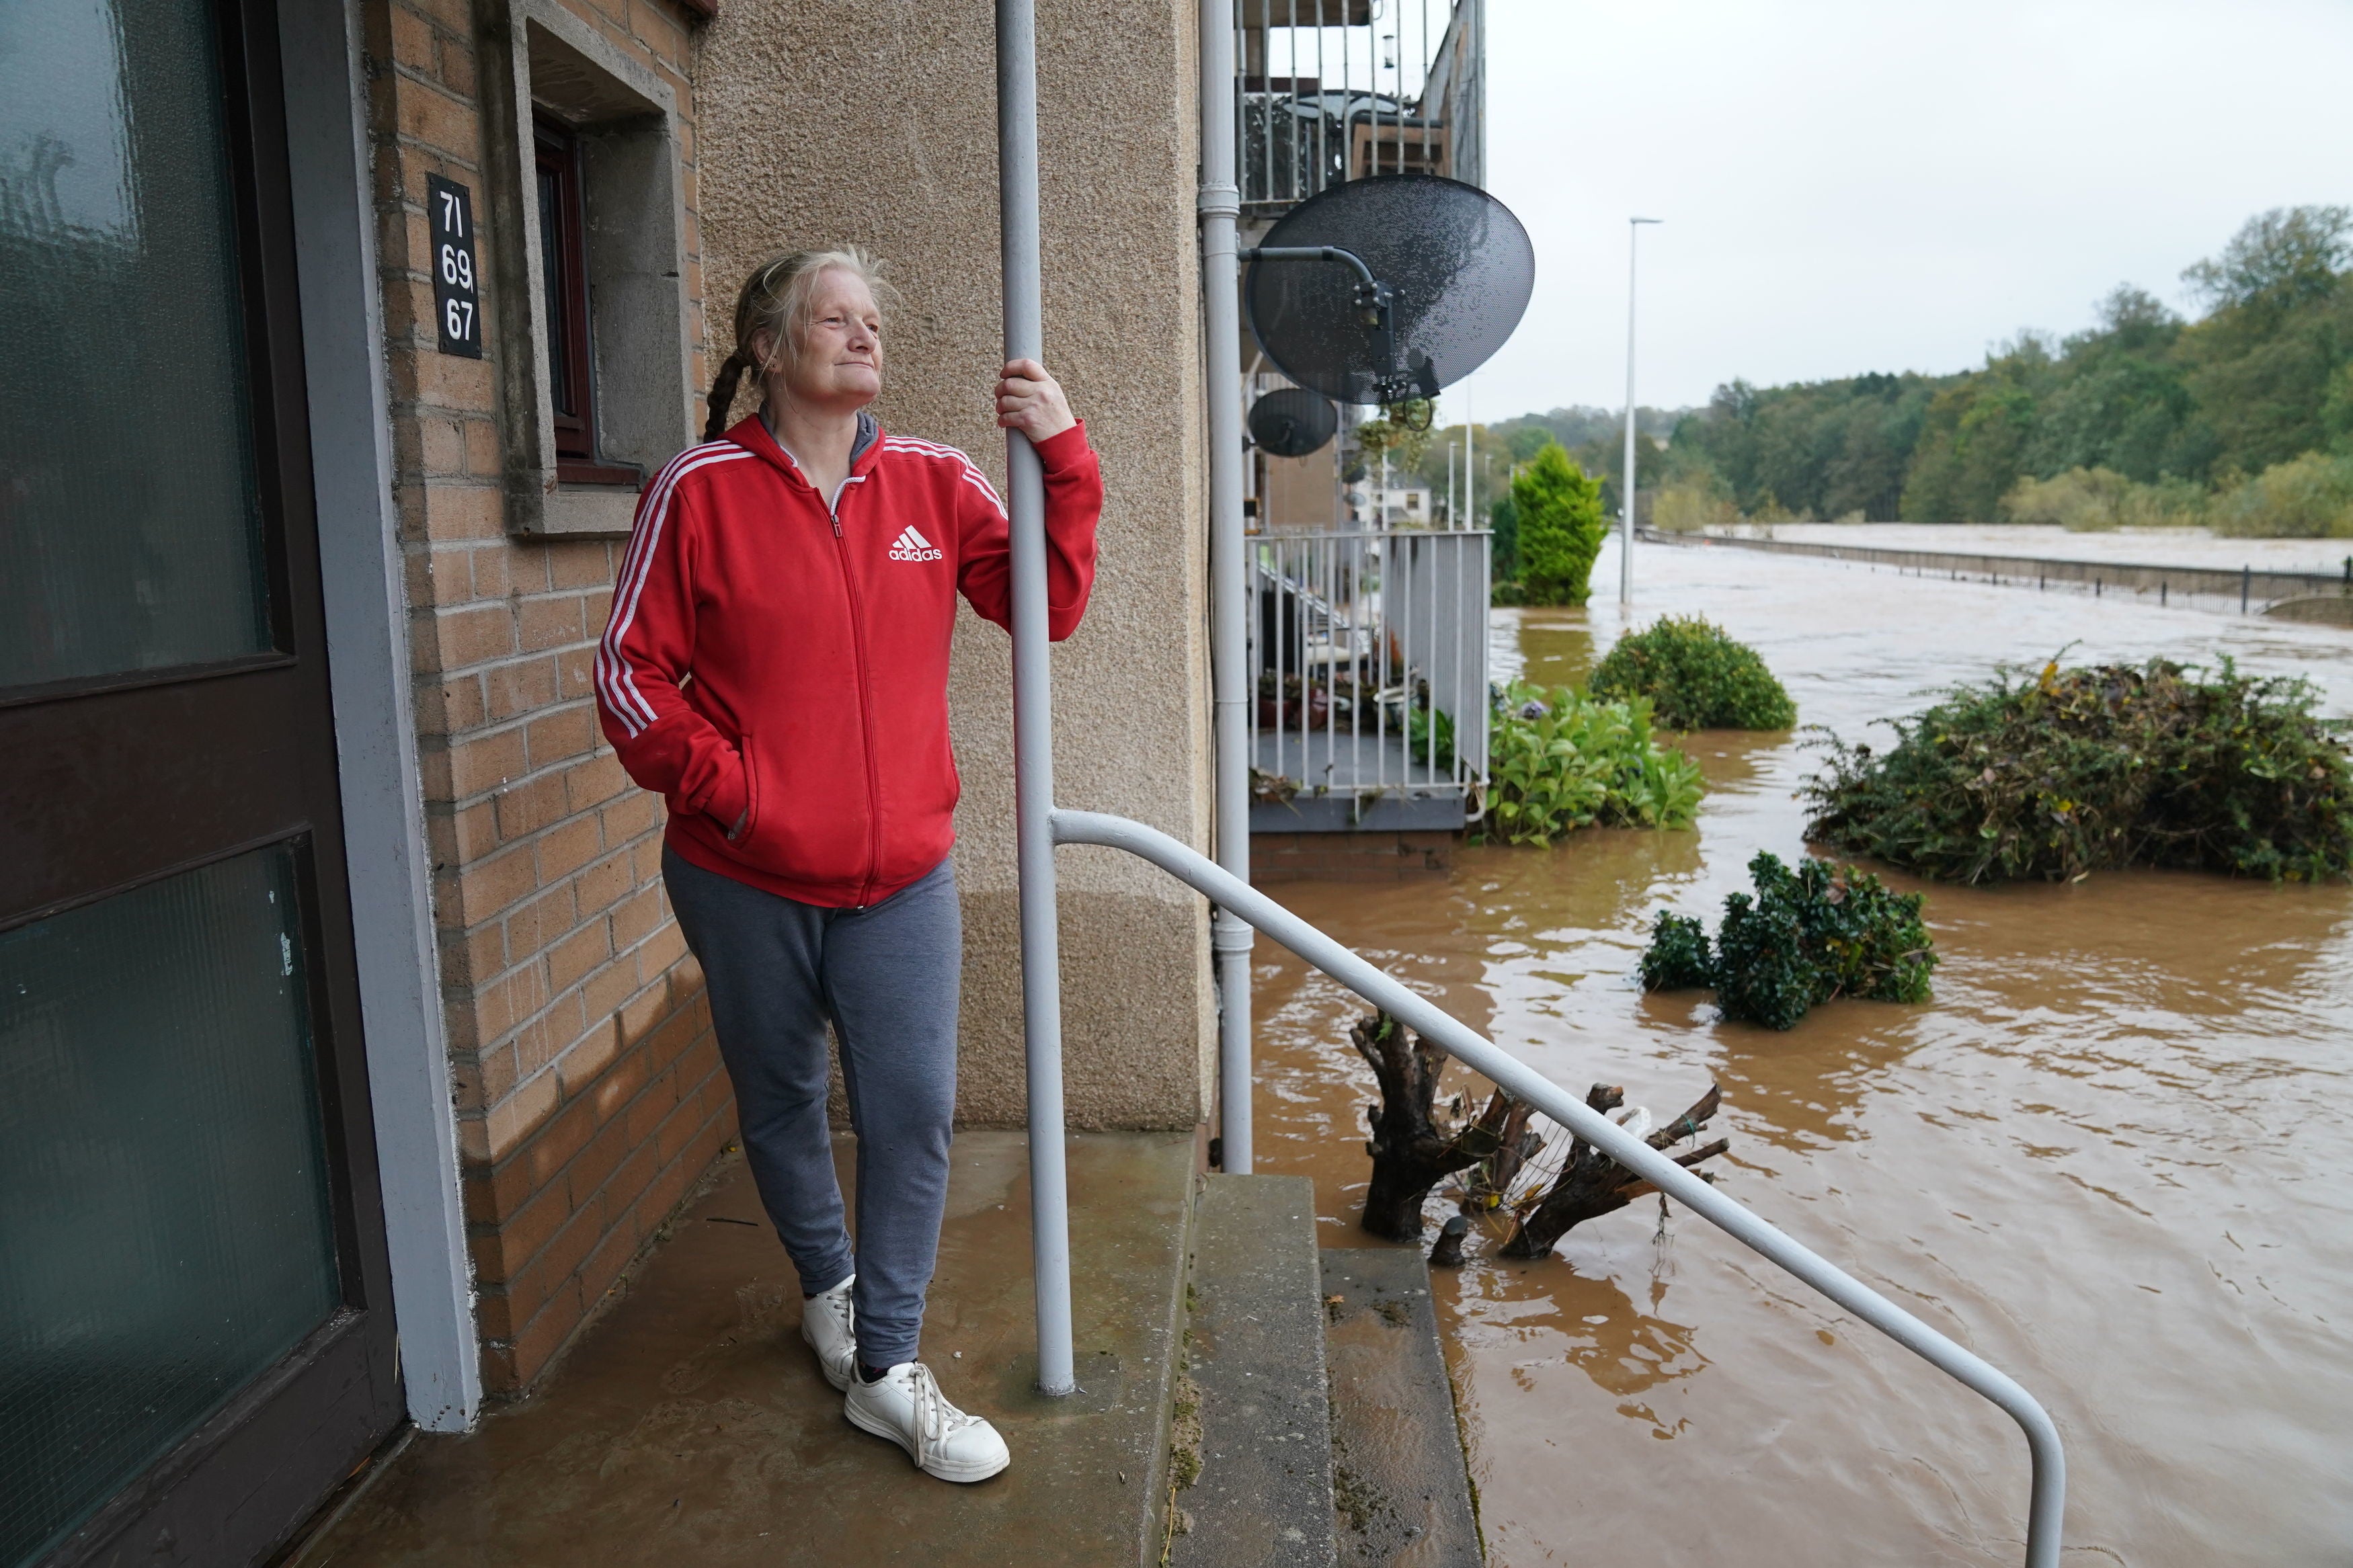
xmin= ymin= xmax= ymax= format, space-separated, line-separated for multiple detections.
xmin=0 ymin=0 xmax=271 ymax=686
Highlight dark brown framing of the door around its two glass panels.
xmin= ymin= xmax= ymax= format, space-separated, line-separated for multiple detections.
xmin=0 ymin=0 xmax=403 ymax=1568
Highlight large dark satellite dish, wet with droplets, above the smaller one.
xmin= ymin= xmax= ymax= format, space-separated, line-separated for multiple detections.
xmin=1242 ymin=174 xmax=1537 ymax=405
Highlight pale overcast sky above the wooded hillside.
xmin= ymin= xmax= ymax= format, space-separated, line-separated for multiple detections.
xmin=1445 ymin=0 xmax=2353 ymax=421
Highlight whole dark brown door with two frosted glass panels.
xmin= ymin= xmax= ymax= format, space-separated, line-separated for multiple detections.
xmin=0 ymin=0 xmax=400 ymax=1568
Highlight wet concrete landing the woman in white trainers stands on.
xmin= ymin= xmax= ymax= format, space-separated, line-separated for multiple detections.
xmin=294 ymin=1133 xmax=1193 ymax=1568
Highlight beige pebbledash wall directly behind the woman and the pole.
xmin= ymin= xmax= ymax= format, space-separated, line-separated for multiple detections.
xmin=696 ymin=0 xmax=1214 ymax=1128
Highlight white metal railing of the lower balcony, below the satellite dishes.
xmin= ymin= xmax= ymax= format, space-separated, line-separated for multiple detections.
xmin=1250 ymin=529 xmax=1490 ymax=816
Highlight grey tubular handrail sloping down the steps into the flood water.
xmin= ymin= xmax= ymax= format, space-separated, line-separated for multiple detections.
xmin=1049 ymin=811 xmax=2066 ymax=1568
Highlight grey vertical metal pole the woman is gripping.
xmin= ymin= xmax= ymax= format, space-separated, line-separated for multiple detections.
xmin=998 ymin=0 xmax=1078 ymax=1394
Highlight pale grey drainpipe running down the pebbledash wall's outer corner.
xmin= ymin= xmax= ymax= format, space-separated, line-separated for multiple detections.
xmin=1198 ymin=0 xmax=1254 ymax=1175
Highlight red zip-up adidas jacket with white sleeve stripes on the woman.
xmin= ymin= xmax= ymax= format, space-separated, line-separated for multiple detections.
xmin=596 ymin=416 xmax=1104 ymax=907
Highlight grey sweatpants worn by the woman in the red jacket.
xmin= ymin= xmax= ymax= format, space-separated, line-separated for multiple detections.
xmin=662 ymin=849 xmax=965 ymax=1366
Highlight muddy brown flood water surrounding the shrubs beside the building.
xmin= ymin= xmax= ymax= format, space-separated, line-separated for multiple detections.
xmin=1257 ymin=533 xmax=2353 ymax=1568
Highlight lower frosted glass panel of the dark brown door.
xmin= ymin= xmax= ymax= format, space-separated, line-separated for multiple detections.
xmin=0 ymin=849 xmax=342 ymax=1563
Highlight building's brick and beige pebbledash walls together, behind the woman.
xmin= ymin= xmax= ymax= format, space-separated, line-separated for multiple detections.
xmin=362 ymin=0 xmax=1214 ymax=1394
